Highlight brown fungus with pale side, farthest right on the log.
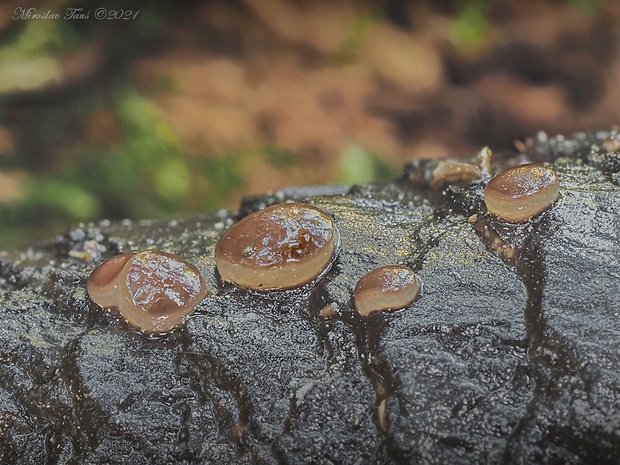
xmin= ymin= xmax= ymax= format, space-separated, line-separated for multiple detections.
xmin=484 ymin=164 xmax=560 ymax=223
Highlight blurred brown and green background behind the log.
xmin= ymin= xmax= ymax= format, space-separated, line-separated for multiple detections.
xmin=0 ymin=0 xmax=620 ymax=249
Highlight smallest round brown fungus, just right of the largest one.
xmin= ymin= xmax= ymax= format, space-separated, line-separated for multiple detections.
xmin=353 ymin=265 xmax=420 ymax=316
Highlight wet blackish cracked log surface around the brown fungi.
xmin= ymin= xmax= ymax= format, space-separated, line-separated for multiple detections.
xmin=0 ymin=134 xmax=620 ymax=464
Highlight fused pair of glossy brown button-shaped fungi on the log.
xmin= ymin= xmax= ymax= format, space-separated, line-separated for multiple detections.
xmin=86 ymin=250 xmax=206 ymax=334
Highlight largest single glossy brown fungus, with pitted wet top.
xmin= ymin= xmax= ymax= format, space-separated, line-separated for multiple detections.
xmin=215 ymin=203 xmax=340 ymax=290
